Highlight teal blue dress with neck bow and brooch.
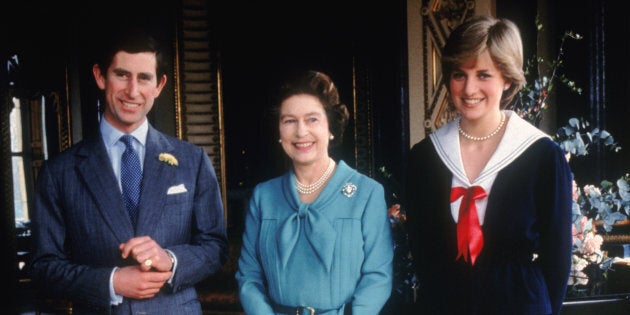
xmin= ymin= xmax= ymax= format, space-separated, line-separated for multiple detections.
xmin=236 ymin=161 xmax=393 ymax=314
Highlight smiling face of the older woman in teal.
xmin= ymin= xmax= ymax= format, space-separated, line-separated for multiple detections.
xmin=279 ymin=94 xmax=330 ymax=164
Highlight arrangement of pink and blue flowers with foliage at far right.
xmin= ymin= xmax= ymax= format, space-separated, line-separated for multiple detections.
xmin=509 ymin=19 xmax=630 ymax=297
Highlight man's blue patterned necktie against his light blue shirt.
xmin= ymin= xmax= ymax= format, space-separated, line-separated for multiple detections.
xmin=120 ymin=135 xmax=142 ymax=228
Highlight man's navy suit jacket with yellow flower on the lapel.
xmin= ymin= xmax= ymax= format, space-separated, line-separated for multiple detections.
xmin=31 ymin=126 xmax=228 ymax=314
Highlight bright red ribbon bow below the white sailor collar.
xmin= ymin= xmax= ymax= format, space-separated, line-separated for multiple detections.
xmin=451 ymin=186 xmax=487 ymax=265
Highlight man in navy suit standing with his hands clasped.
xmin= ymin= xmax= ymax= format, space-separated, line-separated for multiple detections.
xmin=31 ymin=30 xmax=228 ymax=314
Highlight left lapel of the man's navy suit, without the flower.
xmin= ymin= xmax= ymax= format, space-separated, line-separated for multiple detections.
xmin=77 ymin=137 xmax=133 ymax=243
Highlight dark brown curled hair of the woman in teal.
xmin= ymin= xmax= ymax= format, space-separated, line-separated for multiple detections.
xmin=273 ymin=70 xmax=350 ymax=147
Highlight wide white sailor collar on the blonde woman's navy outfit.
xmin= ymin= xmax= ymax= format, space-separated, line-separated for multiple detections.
xmin=429 ymin=110 xmax=549 ymax=186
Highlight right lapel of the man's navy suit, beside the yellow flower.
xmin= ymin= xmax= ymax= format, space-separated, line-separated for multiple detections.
xmin=136 ymin=126 xmax=177 ymax=235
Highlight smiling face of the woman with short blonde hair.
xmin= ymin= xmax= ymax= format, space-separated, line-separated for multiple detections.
xmin=449 ymin=50 xmax=509 ymax=119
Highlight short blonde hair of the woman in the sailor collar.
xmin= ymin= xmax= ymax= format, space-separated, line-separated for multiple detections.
xmin=442 ymin=15 xmax=526 ymax=107
